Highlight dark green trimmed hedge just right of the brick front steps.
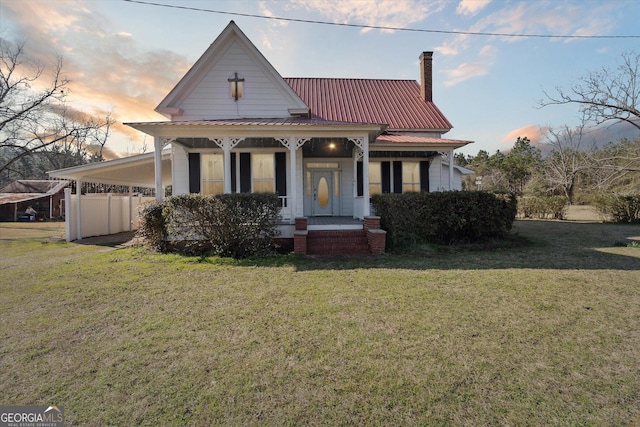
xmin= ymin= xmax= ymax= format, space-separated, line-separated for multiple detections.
xmin=372 ymin=191 xmax=517 ymax=250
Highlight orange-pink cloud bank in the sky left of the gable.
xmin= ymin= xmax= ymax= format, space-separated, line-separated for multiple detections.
xmin=2 ymin=0 xmax=191 ymax=155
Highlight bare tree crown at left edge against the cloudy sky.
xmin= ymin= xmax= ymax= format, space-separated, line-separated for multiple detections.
xmin=0 ymin=38 xmax=113 ymax=173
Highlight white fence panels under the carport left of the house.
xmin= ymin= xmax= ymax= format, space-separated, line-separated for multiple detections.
xmin=65 ymin=189 xmax=155 ymax=242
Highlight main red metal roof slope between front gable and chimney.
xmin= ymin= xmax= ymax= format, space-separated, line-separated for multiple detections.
xmin=284 ymin=78 xmax=453 ymax=132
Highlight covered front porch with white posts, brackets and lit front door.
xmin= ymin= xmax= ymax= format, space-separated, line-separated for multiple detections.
xmin=128 ymin=119 xmax=383 ymax=224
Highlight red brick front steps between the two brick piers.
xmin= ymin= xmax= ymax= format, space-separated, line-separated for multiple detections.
xmin=307 ymin=230 xmax=370 ymax=255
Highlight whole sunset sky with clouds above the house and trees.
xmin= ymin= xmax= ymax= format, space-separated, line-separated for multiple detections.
xmin=0 ymin=0 xmax=640 ymax=155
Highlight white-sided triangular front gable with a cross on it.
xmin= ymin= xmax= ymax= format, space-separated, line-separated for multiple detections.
xmin=156 ymin=21 xmax=308 ymax=121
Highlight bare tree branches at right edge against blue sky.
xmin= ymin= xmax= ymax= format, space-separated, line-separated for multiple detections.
xmin=539 ymin=52 xmax=640 ymax=130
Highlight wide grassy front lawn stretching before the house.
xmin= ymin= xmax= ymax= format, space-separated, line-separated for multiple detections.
xmin=0 ymin=221 xmax=640 ymax=426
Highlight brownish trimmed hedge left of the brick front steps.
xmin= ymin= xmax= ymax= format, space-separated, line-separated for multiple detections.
xmin=136 ymin=193 xmax=279 ymax=258
